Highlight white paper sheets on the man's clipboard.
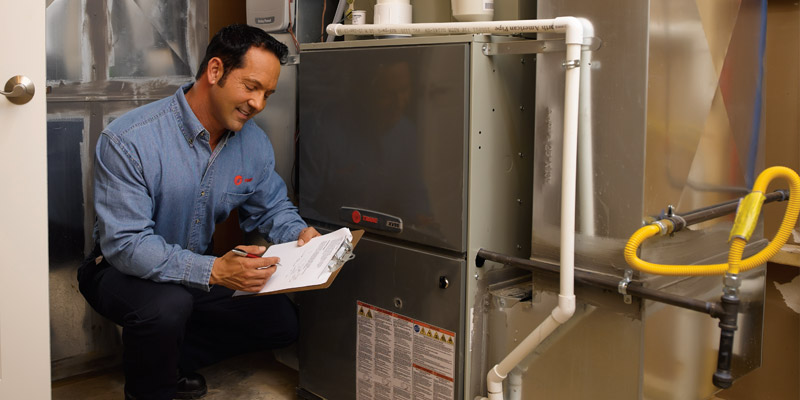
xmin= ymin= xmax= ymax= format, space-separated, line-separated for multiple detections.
xmin=234 ymin=228 xmax=353 ymax=296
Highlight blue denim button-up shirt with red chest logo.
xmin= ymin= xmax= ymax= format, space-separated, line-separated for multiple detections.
xmin=94 ymin=84 xmax=306 ymax=290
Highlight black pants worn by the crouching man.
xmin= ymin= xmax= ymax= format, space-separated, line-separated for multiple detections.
xmin=78 ymin=254 xmax=297 ymax=399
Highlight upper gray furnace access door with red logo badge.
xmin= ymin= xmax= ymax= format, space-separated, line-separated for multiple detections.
xmin=299 ymin=43 xmax=469 ymax=252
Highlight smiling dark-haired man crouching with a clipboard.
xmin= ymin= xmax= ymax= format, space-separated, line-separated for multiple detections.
xmin=78 ymin=25 xmax=319 ymax=400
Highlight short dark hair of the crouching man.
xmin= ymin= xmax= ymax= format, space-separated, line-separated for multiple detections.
xmin=195 ymin=24 xmax=289 ymax=86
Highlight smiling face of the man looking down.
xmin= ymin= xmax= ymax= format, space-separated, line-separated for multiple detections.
xmin=209 ymin=47 xmax=281 ymax=131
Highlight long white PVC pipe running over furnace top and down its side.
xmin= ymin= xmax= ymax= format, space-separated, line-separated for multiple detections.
xmin=326 ymin=17 xmax=583 ymax=400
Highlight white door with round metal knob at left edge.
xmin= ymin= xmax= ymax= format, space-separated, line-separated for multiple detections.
xmin=0 ymin=0 xmax=50 ymax=400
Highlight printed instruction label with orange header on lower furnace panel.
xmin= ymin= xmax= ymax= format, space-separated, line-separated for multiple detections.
xmin=356 ymin=301 xmax=456 ymax=400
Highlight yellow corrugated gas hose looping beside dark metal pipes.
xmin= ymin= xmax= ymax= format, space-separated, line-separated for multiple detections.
xmin=625 ymin=167 xmax=800 ymax=276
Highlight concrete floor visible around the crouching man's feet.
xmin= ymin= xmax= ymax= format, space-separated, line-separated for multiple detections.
xmin=52 ymin=352 xmax=298 ymax=400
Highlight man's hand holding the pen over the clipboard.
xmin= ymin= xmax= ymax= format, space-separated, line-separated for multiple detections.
xmin=208 ymin=246 xmax=280 ymax=292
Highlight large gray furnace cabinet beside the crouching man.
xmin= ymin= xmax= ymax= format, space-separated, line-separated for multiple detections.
xmin=296 ymin=35 xmax=535 ymax=400
